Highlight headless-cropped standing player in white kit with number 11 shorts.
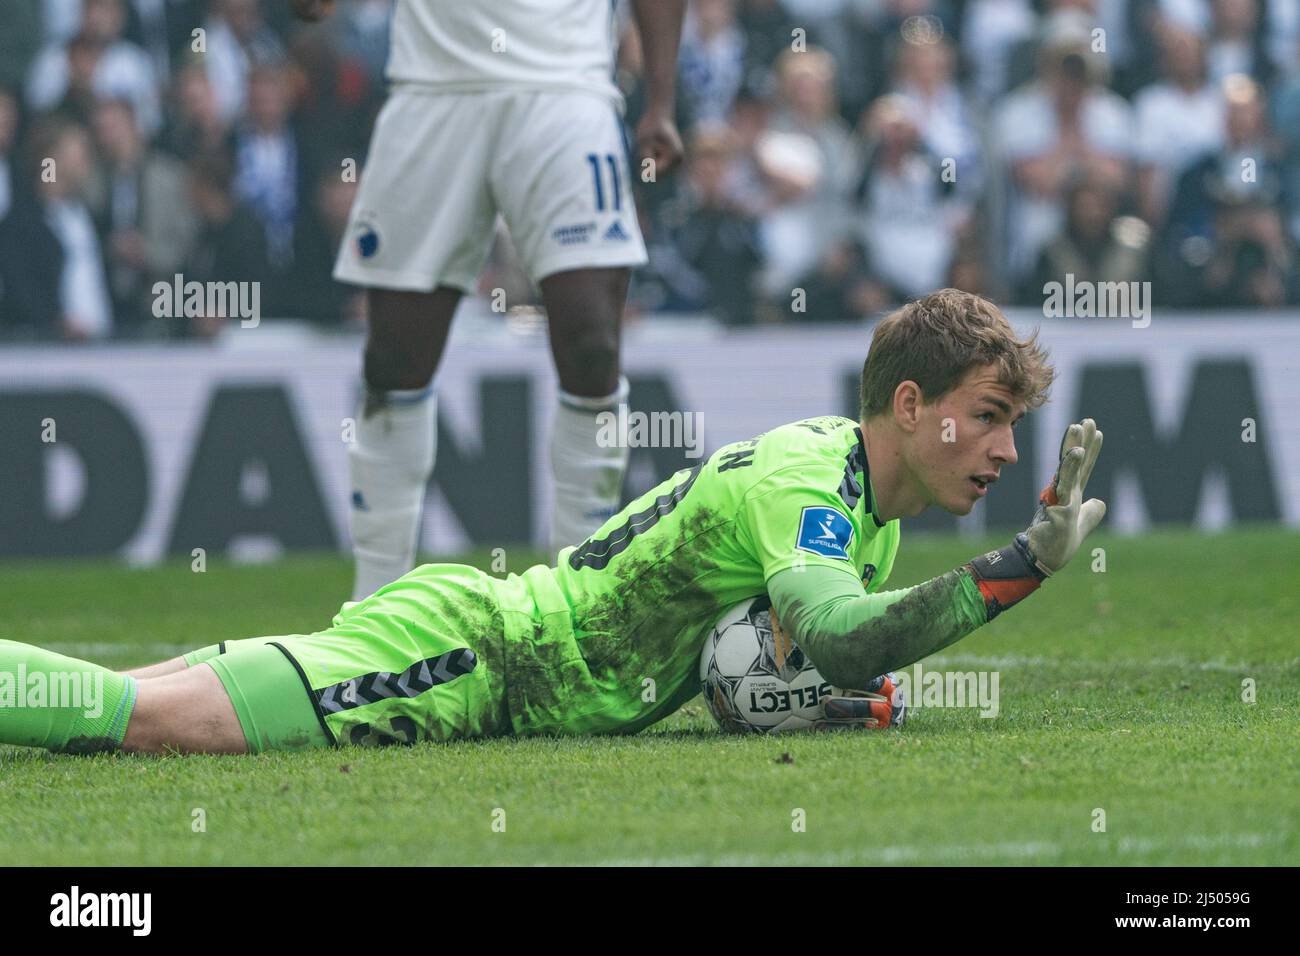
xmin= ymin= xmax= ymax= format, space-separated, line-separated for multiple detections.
xmin=290 ymin=0 xmax=685 ymax=600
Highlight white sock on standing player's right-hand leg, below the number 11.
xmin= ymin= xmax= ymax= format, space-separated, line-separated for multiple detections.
xmin=551 ymin=376 xmax=628 ymax=557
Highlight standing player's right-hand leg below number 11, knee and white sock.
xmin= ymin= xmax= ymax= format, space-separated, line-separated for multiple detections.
xmin=541 ymin=268 xmax=631 ymax=551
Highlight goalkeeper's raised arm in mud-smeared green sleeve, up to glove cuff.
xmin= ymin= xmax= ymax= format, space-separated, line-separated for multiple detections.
xmin=767 ymin=542 xmax=1043 ymax=688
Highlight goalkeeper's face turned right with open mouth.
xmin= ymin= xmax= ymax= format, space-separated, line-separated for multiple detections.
xmin=909 ymin=365 xmax=1026 ymax=515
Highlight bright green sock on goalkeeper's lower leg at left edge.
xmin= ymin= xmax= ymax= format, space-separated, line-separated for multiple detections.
xmin=0 ymin=640 xmax=137 ymax=753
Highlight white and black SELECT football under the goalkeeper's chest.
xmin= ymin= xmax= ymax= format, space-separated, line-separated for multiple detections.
xmin=699 ymin=594 xmax=832 ymax=734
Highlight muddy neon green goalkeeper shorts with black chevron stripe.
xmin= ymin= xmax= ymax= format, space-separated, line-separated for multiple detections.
xmin=186 ymin=564 xmax=510 ymax=753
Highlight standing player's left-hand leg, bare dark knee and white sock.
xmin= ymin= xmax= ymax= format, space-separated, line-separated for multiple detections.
xmin=348 ymin=286 xmax=462 ymax=600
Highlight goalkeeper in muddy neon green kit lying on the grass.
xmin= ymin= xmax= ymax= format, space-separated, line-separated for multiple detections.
xmin=0 ymin=290 xmax=1105 ymax=753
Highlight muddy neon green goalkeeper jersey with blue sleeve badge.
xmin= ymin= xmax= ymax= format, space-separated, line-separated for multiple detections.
xmin=491 ymin=416 xmax=900 ymax=734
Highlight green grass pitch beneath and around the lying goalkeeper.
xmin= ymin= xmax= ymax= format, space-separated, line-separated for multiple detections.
xmin=0 ymin=529 xmax=1300 ymax=866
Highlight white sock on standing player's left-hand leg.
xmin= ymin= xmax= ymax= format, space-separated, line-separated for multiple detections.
xmin=347 ymin=388 xmax=437 ymax=601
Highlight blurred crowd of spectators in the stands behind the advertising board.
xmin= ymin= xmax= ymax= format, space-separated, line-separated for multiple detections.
xmin=0 ymin=0 xmax=1300 ymax=339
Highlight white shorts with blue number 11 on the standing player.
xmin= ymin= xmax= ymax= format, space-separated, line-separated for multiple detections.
xmin=334 ymin=85 xmax=646 ymax=291
